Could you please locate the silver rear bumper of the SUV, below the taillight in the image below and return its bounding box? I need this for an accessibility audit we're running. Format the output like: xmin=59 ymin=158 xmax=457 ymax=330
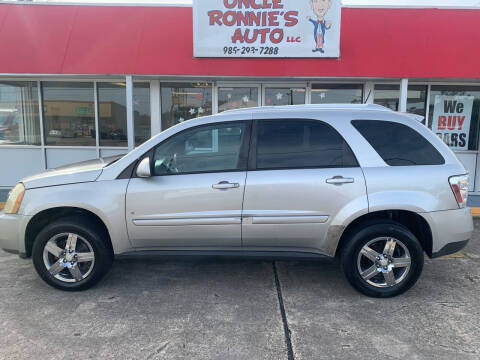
xmin=421 ymin=207 xmax=473 ymax=258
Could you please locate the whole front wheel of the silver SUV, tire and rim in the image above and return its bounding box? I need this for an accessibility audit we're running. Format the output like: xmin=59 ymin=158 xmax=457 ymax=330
xmin=32 ymin=217 xmax=113 ymax=291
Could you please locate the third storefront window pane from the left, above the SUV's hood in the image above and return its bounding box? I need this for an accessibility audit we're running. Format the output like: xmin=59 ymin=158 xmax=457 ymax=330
xmin=97 ymin=82 xmax=128 ymax=147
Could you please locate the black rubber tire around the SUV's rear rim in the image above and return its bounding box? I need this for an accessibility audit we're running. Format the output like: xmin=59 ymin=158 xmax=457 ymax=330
xmin=341 ymin=220 xmax=424 ymax=298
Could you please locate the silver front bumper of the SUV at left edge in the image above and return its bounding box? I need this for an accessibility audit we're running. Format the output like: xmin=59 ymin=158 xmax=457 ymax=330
xmin=0 ymin=211 xmax=30 ymax=254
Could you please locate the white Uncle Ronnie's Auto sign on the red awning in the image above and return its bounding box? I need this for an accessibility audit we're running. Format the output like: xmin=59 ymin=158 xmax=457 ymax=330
xmin=193 ymin=0 xmax=341 ymax=58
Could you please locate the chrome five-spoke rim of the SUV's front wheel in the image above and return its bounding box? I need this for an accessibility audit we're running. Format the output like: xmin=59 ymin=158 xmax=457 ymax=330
xmin=43 ymin=233 xmax=95 ymax=283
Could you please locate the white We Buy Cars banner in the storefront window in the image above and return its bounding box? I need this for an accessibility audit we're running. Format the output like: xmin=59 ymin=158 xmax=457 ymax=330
xmin=432 ymin=95 xmax=474 ymax=150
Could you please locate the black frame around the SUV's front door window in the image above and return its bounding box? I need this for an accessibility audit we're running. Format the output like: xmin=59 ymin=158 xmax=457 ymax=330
xmin=131 ymin=120 xmax=252 ymax=179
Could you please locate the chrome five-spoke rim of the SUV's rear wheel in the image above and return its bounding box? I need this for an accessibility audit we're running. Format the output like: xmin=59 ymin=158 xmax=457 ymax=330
xmin=357 ymin=237 xmax=412 ymax=288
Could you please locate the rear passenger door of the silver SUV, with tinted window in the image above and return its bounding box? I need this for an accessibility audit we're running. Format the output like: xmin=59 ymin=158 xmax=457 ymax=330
xmin=242 ymin=119 xmax=368 ymax=253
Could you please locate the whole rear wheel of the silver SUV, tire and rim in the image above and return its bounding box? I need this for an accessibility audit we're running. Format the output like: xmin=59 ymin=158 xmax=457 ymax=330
xmin=341 ymin=222 xmax=423 ymax=297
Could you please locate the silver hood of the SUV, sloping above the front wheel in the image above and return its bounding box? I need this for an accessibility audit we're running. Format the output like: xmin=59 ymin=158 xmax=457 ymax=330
xmin=20 ymin=156 xmax=120 ymax=189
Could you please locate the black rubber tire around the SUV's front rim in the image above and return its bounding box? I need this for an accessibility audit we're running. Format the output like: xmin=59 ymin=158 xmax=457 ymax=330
xmin=32 ymin=216 xmax=113 ymax=291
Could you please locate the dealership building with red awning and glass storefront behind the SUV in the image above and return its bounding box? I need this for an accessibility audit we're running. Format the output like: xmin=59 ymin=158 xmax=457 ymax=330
xmin=0 ymin=0 xmax=480 ymax=205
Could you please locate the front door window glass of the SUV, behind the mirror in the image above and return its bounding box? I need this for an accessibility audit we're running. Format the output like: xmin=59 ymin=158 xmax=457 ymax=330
xmin=153 ymin=122 xmax=248 ymax=175
